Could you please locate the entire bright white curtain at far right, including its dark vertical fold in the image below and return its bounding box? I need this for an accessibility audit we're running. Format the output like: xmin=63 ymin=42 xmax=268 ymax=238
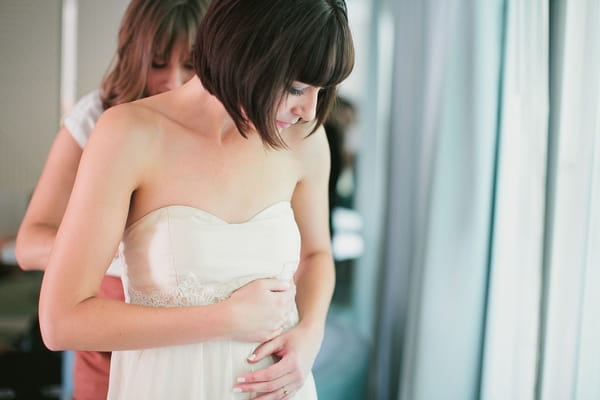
xmin=481 ymin=0 xmax=600 ymax=400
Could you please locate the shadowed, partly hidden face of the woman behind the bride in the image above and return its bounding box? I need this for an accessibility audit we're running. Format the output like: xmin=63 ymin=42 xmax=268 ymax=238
xmin=146 ymin=40 xmax=194 ymax=96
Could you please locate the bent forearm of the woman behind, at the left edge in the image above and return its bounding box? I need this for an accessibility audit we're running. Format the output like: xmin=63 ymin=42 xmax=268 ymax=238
xmin=15 ymin=224 xmax=57 ymax=271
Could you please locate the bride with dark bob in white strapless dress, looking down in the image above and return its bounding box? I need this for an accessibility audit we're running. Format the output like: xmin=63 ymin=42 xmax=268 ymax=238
xmin=40 ymin=0 xmax=354 ymax=400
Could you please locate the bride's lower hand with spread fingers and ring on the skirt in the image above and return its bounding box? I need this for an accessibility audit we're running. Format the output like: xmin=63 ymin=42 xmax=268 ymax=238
xmin=234 ymin=325 xmax=323 ymax=400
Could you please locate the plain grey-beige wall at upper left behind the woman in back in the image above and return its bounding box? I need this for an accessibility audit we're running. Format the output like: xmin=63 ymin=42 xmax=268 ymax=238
xmin=0 ymin=0 xmax=128 ymax=236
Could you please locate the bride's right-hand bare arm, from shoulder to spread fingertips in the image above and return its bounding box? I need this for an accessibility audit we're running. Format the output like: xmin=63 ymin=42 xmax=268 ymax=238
xmin=235 ymin=128 xmax=335 ymax=400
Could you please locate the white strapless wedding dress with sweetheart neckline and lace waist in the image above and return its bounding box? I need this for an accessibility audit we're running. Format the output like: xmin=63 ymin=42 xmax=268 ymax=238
xmin=108 ymin=201 xmax=317 ymax=400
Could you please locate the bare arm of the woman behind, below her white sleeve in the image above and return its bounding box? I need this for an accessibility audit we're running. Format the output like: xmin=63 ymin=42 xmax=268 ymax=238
xmin=15 ymin=127 xmax=82 ymax=270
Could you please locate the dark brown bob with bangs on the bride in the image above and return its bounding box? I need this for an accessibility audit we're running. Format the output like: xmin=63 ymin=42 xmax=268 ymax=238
xmin=194 ymin=0 xmax=354 ymax=148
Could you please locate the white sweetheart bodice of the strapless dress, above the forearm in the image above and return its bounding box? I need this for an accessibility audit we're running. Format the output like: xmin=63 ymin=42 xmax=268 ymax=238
xmin=123 ymin=201 xmax=300 ymax=306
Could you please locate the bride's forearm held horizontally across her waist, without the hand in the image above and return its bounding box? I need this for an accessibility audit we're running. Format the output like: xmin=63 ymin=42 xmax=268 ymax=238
xmin=40 ymin=296 xmax=231 ymax=351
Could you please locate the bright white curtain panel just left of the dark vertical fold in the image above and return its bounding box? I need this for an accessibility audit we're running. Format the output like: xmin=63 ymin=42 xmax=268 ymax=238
xmin=481 ymin=0 xmax=549 ymax=400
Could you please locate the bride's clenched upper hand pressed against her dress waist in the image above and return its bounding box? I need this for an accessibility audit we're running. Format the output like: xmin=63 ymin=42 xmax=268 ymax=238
xmin=226 ymin=279 xmax=296 ymax=342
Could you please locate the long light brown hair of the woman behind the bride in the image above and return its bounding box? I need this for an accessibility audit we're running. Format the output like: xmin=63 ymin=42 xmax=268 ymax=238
xmin=101 ymin=0 xmax=209 ymax=109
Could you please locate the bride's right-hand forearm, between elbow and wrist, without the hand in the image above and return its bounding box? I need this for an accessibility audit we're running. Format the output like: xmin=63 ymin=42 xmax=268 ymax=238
xmin=296 ymin=252 xmax=335 ymax=335
